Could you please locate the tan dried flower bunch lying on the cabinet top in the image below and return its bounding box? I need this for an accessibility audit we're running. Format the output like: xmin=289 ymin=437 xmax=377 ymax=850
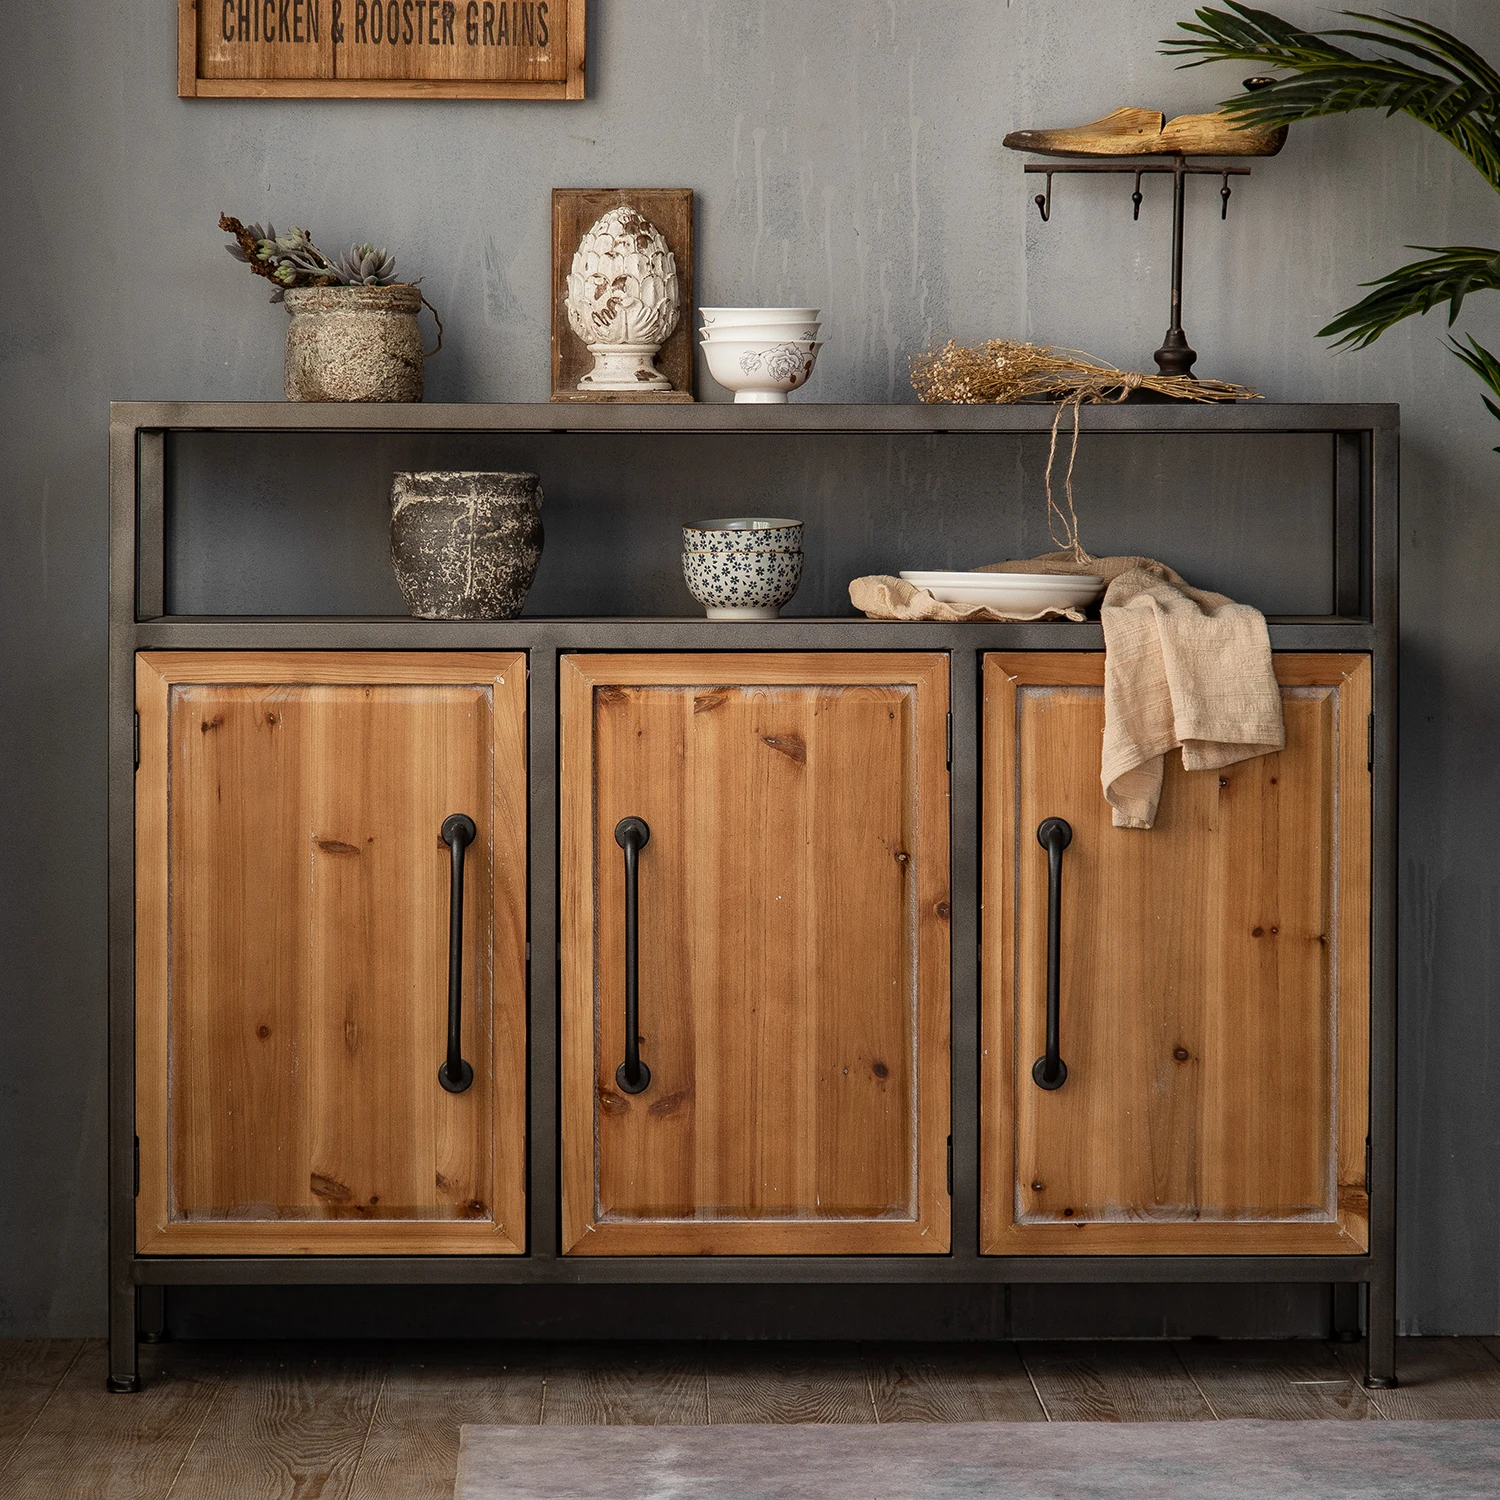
xmin=912 ymin=339 xmax=1259 ymax=405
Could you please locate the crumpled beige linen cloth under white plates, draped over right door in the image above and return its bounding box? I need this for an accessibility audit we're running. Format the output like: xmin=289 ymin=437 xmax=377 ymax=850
xmin=849 ymin=552 xmax=1286 ymax=828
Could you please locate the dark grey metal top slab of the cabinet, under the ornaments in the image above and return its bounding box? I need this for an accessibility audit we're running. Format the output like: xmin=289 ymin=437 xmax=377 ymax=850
xmin=110 ymin=401 xmax=1401 ymax=434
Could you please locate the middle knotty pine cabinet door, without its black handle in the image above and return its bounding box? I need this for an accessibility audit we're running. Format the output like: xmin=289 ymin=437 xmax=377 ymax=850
xmin=561 ymin=653 xmax=948 ymax=1256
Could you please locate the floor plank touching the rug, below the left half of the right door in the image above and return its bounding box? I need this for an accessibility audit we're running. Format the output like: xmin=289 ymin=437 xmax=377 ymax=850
xmin=1017 ymin=1343 xmax=1214 ymax=1422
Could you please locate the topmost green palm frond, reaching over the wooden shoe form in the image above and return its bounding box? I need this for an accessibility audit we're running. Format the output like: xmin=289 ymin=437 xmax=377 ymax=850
xmin=1161 ymin=0 xmax=1500 ymax=192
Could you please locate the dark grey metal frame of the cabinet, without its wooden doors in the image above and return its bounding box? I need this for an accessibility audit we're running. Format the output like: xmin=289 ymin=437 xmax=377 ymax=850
xmin=108 ymin=402 xmax=1398 ymax=1391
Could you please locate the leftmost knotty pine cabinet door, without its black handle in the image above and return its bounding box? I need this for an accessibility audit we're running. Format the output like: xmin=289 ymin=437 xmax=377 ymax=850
xmin=137 ymin=651 xmax=527 ymax=1254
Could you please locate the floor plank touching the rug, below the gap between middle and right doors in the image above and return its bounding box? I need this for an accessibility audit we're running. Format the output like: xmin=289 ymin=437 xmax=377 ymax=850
xmin=864 ymin=1344 xmax=1047 ymax=1422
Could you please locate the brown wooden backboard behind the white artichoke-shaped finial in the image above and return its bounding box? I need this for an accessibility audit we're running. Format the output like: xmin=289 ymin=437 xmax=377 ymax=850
xmin=552 ymin=188 xmax=698 ymax=404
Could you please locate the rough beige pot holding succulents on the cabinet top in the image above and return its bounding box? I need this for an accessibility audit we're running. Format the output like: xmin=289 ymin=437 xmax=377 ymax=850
xmin=287 ymin=287 xmax=423 ymax=401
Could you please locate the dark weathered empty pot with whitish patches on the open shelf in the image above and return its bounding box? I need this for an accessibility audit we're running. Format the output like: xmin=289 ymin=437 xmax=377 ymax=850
xmin=390 ymin=473 xmax=542 ymax=620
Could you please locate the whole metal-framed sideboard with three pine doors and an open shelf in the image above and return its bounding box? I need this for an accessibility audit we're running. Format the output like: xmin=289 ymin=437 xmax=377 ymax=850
xmin=110 ymin=404 xmax=1397 ymax=1391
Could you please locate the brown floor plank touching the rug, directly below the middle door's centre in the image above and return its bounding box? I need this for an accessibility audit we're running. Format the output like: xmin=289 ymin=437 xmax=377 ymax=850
xmin=708 ymin=1344 xmax=876 ymax=1424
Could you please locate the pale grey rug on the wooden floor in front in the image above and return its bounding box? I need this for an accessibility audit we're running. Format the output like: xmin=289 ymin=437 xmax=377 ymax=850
xmin=456 ymin=1422 xmax=1500 ymax=1500
